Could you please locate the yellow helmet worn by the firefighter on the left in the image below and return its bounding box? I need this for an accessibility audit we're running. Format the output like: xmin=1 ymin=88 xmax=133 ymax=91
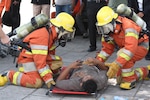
xmin=50 ymin=12 xmax=75 ymax=32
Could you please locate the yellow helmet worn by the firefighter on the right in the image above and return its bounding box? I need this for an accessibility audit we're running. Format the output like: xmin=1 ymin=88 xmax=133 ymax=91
xmin=96 ymin=6 xmax=118 ymax=26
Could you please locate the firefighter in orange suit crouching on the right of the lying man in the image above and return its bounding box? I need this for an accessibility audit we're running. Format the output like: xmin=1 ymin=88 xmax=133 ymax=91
xmin=96 ymin=6 xmax=150 ymax=90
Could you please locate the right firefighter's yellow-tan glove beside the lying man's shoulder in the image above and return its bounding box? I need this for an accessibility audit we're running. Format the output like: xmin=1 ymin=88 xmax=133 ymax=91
xmin=105 ymin=62 xmax=120 ymax=78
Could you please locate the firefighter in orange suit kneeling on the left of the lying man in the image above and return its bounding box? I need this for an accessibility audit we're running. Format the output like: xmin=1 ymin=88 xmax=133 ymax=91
xmin=0 ymin=12 xmax=75 ymax=88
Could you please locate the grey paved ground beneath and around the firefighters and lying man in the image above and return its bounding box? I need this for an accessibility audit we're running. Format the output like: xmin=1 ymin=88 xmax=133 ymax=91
xmin=0 ymin=36 xmax=150 ymax=100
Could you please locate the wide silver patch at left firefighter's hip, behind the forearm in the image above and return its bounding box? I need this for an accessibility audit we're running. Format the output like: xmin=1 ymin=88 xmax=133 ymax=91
xmin=22 ymin=62 xmax=37 ymax=72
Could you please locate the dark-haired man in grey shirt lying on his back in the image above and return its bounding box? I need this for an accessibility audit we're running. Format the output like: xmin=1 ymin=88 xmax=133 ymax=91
xmin=56 ymin=58 xmax=108 ymax=93
